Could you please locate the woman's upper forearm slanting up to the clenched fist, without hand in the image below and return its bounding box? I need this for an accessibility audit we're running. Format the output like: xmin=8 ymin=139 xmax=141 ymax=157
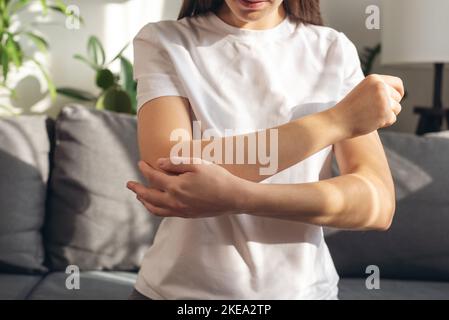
xmin=175 ymin=110 xmax=347 ymax=182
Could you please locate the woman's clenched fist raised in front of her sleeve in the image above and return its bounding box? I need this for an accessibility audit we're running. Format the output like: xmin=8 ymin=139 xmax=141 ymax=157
xmin=329 ymin=75 xmax=404 ymax=138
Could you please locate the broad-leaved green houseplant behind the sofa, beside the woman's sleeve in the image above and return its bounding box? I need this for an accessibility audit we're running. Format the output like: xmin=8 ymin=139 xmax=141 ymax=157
xmin=57 ymin=36 xmax=137 ymax=114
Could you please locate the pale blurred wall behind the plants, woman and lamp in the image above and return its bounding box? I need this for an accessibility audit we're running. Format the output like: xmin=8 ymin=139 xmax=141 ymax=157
xmin=0 ymin=0 xmax=449 ymax=132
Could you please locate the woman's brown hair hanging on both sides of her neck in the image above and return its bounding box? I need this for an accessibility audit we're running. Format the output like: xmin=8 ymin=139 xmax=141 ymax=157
xmin=178 ymin=0 xmax=323 ymax=26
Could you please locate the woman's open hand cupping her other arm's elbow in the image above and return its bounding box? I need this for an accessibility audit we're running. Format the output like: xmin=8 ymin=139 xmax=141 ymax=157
xmin=127 ymin=159 xmax=251 ymax=218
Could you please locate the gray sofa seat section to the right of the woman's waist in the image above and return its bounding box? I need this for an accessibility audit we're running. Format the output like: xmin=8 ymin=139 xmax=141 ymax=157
xmin=338 ymin=278 xmax=449 ymax=300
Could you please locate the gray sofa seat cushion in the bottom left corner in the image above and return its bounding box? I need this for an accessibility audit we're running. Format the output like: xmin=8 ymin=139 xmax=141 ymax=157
xmin=0 ymin=273 xmax=44 ymax=300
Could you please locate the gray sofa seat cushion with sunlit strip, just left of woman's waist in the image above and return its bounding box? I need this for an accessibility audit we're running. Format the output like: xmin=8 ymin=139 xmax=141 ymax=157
xmin=28 ymin=271 xmax=137 ymax=300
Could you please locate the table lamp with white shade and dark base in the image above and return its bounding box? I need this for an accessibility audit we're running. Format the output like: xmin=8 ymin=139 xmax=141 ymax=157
xmin=381 ymin=0 xmax=449 ymax=135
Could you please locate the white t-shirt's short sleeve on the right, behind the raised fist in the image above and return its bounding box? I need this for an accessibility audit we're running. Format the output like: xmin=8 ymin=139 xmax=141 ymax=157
xmin=338 ymin=32 xmax=365 ymax=99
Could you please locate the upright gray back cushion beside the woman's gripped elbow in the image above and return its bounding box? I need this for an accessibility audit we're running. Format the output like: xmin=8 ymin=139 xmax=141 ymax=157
xmin=45 ymin=106 xmax=159 ymax=271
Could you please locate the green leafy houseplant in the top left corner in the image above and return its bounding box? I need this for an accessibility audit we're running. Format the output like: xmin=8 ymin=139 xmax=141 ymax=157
xmin=0 ymin=0 xmax=76 ymax=114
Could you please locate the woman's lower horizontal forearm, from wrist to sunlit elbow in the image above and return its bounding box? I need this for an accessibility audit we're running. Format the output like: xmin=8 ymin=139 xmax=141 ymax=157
xmin=241 ymin=171 xmax=395 ymax=230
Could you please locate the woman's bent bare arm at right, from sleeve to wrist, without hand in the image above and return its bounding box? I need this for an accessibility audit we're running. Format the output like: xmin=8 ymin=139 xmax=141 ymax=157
xmin=244 ymin=131 xmax=396 ymax=230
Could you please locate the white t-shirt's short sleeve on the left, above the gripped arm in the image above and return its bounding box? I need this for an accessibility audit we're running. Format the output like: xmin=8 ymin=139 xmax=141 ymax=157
xmin=133 ymin=23 xmax=186 ymax=110
